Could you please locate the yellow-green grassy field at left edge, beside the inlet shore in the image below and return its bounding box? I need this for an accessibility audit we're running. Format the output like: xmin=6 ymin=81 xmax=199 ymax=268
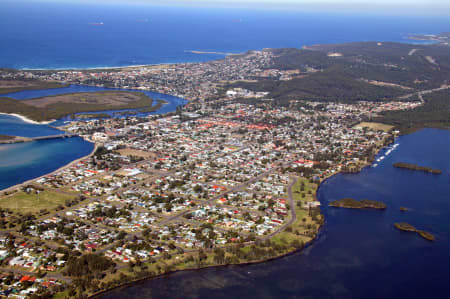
xmin=0 ymin=191 xmax=74 ymax=213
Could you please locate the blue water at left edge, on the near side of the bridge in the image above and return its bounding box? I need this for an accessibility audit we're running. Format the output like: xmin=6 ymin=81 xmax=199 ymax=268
xmin=0 ymin=137 xmax=94 ymax=190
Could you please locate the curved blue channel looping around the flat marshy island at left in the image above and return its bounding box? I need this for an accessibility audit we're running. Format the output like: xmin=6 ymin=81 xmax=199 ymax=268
xmin=0 ymin=85 xmax=188 ymax=123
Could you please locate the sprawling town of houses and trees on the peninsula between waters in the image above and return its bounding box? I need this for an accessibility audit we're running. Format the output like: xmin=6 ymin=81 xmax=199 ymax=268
xmin=0 ymin=50 xmax=422 ymax=297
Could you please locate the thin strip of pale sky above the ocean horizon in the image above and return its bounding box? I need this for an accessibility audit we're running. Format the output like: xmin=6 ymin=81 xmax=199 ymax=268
xmin=15 ymin=0 xmax=450 ymax=15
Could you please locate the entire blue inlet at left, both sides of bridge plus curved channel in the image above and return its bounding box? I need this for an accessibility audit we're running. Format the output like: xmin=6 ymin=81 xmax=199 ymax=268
xmin=0 ymin=85 xmax=187 ymax=190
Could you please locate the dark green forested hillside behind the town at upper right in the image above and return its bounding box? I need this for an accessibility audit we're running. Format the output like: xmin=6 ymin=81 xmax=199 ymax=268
xmin=232 ymin=42 xmax=450 ymax=105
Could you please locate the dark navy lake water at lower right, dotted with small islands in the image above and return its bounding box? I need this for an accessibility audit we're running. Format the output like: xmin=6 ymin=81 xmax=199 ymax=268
xmin=103 ymin=129 xmax=450 ymax=298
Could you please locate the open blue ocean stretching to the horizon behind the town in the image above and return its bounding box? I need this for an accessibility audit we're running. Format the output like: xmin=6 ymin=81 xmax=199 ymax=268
xmin=0 ymin=0 xmax=450 ymax=68
